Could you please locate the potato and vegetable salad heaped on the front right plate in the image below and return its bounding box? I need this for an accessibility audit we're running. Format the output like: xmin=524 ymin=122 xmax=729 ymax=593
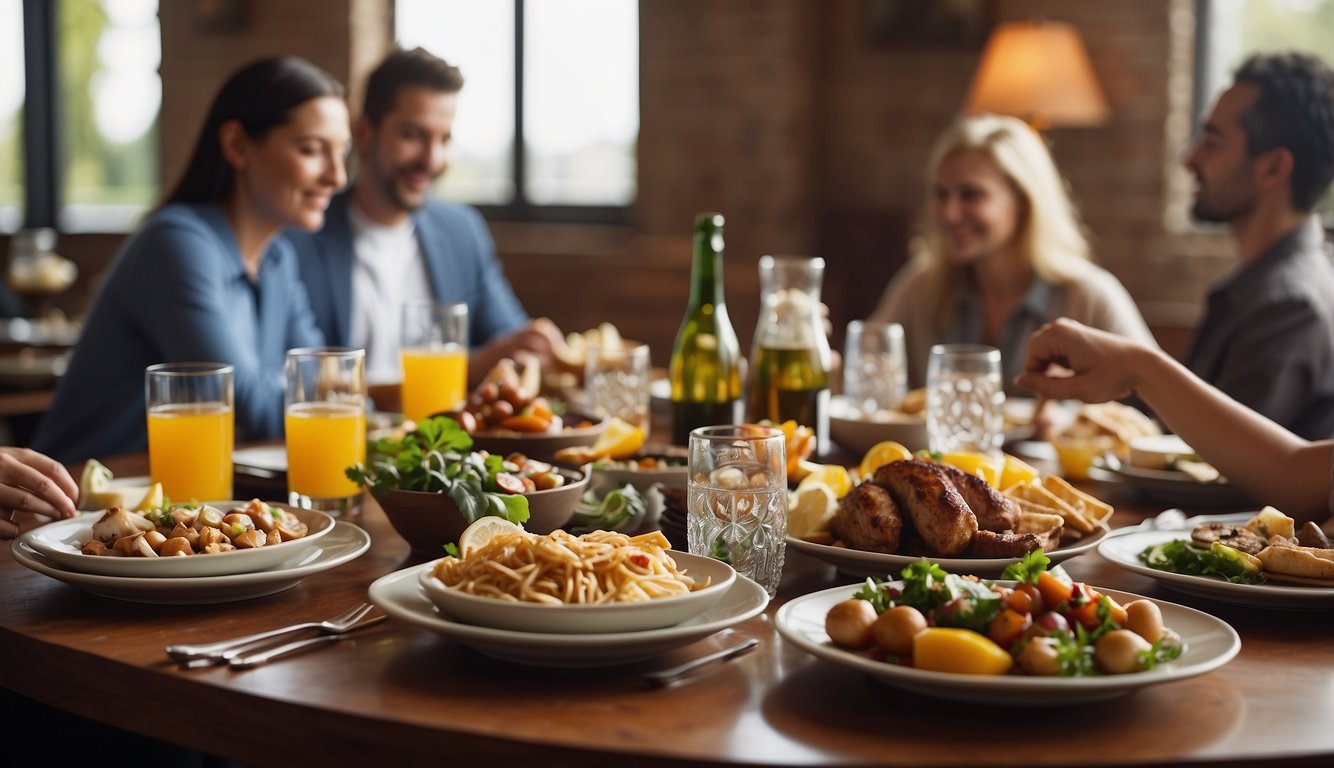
xmin=824 ymin=551 xmax=1185 ymax=677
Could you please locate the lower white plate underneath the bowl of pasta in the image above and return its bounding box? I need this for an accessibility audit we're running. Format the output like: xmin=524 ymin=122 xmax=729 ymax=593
xmin=371 ymin=563 xmax=768 ymax=668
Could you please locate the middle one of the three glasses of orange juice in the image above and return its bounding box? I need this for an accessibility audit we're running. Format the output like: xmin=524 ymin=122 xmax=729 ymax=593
xmin=284 ymin=347 xmax=366 ymax=517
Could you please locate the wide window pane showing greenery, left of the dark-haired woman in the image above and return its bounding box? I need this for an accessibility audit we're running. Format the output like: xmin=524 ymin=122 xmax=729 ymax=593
xmin=56 ymin=0 xmax=161 ymax=231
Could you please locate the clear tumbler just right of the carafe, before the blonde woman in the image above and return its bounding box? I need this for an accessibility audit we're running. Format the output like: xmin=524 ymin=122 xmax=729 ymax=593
xmin=843 ymin=320 xmax=908 ymax=417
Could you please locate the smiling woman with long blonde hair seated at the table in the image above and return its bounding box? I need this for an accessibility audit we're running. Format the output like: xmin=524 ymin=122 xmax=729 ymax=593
xmin=870 ymin=115 xmax=1157 ymax=387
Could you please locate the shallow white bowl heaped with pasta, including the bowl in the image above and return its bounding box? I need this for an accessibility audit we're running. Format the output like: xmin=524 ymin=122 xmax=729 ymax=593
xmin=419 ymin=527 xmax=736 ymax=635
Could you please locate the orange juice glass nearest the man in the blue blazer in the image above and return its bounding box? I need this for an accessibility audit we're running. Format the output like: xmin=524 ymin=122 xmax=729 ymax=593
xmin=399 ymin=301 xmax=468 ymax=421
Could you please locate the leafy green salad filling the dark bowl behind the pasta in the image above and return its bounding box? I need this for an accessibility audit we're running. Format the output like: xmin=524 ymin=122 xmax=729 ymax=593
xmin=347 ymin=416 xmax=566 ymax=525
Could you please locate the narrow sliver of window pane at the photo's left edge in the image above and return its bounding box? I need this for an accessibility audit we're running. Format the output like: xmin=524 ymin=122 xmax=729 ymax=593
xmin=0 ymin=0 xmax=24 ymax=232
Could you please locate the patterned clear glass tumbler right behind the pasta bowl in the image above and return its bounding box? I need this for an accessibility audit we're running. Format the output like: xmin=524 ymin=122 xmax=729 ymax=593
xmin=686 ymin=424 xmax=787 ymax=597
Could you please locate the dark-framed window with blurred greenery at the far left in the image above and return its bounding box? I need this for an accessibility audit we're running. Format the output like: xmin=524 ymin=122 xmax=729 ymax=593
xmin=0 ymin=0 xmax=161 ymax=232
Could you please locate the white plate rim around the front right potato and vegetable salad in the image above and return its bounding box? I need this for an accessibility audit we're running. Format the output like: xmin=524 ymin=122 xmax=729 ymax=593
xmin=774 ymin=584 xmax=1242 ymax=704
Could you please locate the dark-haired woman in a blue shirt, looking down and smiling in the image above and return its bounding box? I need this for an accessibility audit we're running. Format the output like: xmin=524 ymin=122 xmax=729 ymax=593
xmin=33 ymin=57 xmax=350 ymax=463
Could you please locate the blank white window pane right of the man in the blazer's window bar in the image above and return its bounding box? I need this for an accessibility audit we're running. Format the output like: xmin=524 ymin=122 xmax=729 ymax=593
xmin=523 ymin=0 xmax=639 ymax=205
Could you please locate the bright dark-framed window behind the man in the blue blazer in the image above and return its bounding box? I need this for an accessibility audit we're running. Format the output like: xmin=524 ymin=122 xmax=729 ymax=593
xmin=395 ymin=0 xmax=639 ymax=224
